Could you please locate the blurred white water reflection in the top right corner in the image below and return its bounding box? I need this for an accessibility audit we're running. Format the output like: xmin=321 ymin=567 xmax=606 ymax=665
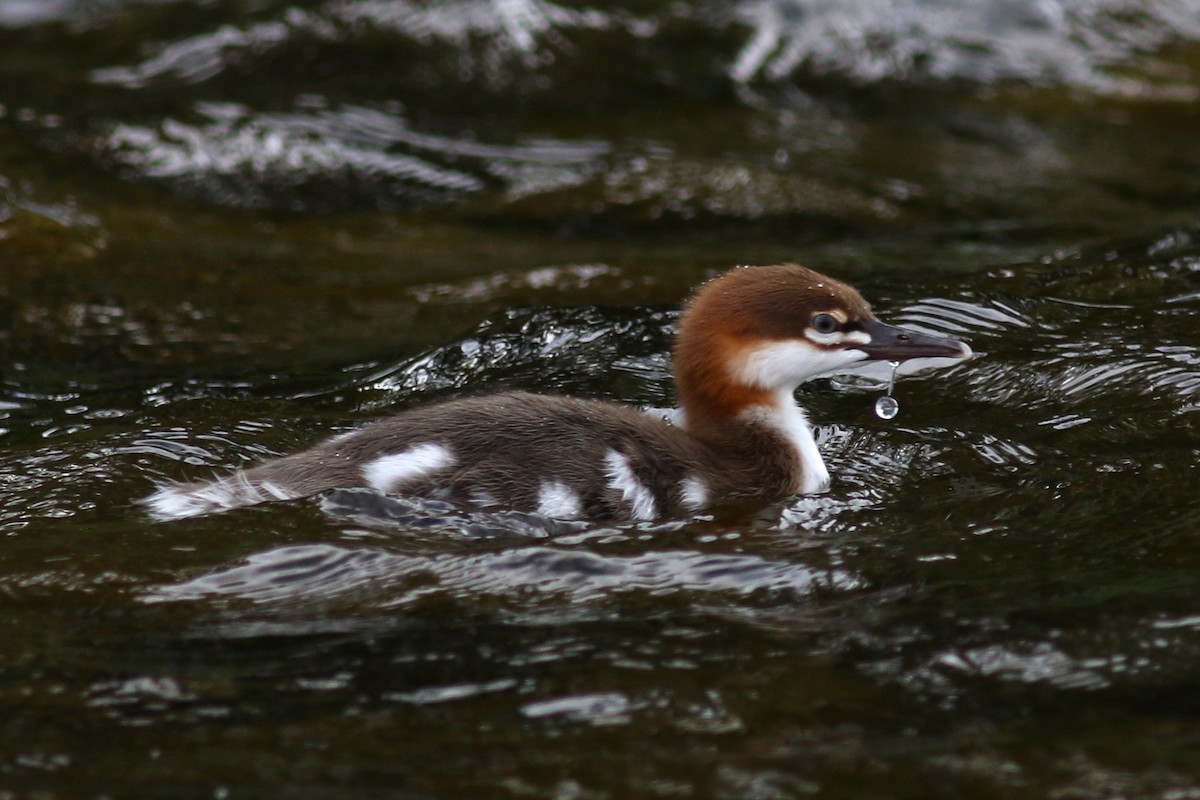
xmin=731 ymin=0 xmax=1200 ymax=92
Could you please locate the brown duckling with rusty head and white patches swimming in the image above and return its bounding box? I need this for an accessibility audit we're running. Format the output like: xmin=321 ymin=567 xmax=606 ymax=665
xmin=143 ymin=264 xmax=971 ymax=521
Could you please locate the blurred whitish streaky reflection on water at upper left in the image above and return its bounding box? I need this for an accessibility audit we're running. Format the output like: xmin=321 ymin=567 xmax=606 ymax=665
xmin=106 ymin=100 xmax=607 ymax=207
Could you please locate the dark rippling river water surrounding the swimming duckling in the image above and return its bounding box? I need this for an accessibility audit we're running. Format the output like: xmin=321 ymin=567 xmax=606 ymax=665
xmin=0 ymin=0 xmax=1200 ymax=800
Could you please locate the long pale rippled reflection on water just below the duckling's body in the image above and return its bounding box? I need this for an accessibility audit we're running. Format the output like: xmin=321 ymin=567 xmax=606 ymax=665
xmin=145 ymin=534 xmax=862 ymax=610
